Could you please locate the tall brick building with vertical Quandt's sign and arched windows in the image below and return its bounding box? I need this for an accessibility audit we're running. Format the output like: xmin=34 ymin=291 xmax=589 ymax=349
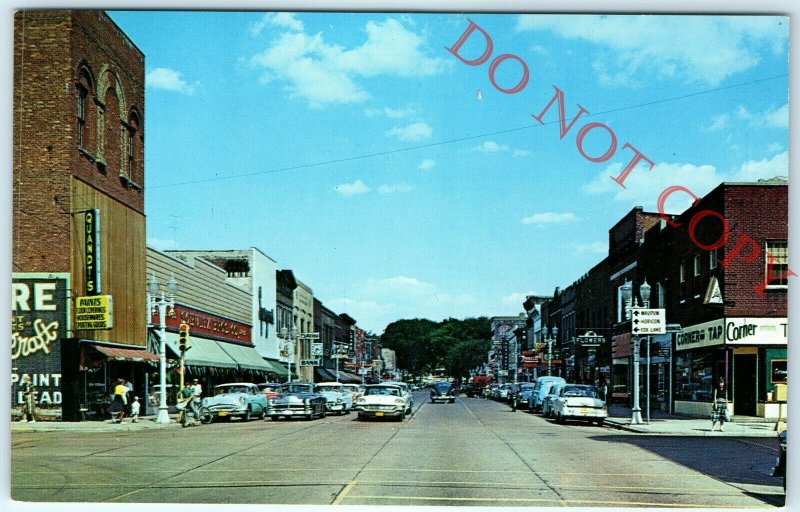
xmin=12 ymin=10 xmax=148 ymax=419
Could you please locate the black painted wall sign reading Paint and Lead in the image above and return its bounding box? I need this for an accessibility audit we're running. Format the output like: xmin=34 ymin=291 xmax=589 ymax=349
xmin=11 ymin=273 xmax=70 ymax=409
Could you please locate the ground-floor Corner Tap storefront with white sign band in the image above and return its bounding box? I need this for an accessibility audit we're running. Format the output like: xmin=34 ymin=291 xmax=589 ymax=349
xmin=674 ymin=317 xmax=788 ymax=418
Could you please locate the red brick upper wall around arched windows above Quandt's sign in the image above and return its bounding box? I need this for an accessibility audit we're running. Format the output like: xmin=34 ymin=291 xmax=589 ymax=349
xmin=12 ymin=10 xmax=144 ymax=272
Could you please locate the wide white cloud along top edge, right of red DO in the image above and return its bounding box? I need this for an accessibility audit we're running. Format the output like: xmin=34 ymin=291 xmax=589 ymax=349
xmin=516 ymin=14 xmax=789 ymax=86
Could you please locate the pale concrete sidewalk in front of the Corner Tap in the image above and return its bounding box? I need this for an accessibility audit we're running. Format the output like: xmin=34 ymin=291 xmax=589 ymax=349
xmin=606 ymin=405 xmax=778 ymax=437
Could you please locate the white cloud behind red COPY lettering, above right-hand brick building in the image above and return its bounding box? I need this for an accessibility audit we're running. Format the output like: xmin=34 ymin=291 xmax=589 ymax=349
xmin=582 ymin=151 xmax=789 ymax=213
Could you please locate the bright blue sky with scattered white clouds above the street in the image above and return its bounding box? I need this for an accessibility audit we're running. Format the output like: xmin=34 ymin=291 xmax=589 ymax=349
xmin=104 ymin=11 xmax=789 ymax=333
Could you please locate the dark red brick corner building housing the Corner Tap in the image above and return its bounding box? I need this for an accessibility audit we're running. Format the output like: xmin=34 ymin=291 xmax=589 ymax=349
xmin=638 ymin=179 xmax=788 ymax=417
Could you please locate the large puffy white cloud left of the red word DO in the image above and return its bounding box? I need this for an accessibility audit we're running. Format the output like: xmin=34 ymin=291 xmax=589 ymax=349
xmin=250 ymin=18 xmax=445 ymax=107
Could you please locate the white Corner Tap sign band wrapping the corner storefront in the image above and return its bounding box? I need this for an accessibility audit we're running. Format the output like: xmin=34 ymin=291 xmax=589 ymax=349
xmin=675 ymin=317 xmax=788 ymax=350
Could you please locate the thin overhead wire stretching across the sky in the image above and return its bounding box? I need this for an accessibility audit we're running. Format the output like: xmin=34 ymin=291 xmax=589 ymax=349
xmin=139 ymin=73 xmax=789 ymax=190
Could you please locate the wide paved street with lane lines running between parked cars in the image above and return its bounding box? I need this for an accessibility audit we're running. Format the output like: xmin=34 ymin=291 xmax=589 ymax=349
xmin=11 ymin=393 xmax=783 ymax=508
